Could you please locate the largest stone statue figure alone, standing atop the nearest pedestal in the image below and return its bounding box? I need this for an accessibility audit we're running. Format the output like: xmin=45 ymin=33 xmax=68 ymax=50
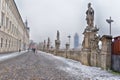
xmin=86 ymin=3 xmax=94 ymax=27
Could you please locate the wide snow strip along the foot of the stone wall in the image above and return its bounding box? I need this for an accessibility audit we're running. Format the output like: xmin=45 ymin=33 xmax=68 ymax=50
xmin=40 ymin=52 xmax=120 ymax=80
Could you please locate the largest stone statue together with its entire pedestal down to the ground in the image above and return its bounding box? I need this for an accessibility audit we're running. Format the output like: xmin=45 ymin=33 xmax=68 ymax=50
xmin=81 ymin=3 xmax=100 ymax=66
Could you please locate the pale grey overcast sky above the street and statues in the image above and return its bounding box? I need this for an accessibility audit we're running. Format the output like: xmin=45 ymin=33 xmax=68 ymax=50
xmin=15 ymin=0 xmax=120 ymax=46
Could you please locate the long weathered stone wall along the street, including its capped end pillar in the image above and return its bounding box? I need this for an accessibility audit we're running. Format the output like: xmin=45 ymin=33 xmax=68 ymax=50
xmin=44 ymin=35 xmax=114 ymax=69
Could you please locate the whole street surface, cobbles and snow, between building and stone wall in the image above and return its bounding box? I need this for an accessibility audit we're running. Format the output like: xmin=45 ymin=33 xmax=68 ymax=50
xmin=0 ymin=51 xmax=120 ymax=80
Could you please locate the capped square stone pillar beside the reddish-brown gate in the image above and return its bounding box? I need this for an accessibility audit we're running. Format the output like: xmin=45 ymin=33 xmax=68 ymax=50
xmin=100 ymin=35 xmax=112 ymax=69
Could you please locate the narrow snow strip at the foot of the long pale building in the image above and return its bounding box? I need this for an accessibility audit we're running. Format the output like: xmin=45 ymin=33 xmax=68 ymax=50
xmin=0 ymin=51 xmax=26 ymax=61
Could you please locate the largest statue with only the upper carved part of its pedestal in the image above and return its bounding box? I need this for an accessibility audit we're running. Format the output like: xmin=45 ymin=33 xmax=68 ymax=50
xmin=82 ymin=3 xmax=100 ymax=51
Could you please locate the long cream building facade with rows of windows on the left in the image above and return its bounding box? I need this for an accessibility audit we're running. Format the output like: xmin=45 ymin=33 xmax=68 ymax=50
xmin=0 ymin=0 xmax=29 ymax=53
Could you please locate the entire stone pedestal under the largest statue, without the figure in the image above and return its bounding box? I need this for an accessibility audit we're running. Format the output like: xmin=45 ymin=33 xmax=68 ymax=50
xmin=82 ymin=27 xmax=99 ymax=66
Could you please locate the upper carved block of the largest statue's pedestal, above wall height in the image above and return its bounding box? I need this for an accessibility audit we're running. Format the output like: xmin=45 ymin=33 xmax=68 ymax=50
xmin=82 ymin=26 xmax=99 ymax=49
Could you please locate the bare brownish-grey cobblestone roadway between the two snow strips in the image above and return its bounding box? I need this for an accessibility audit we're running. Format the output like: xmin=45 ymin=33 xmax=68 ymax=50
xmin=0 ymin=52 xmax=79 ymax=80
